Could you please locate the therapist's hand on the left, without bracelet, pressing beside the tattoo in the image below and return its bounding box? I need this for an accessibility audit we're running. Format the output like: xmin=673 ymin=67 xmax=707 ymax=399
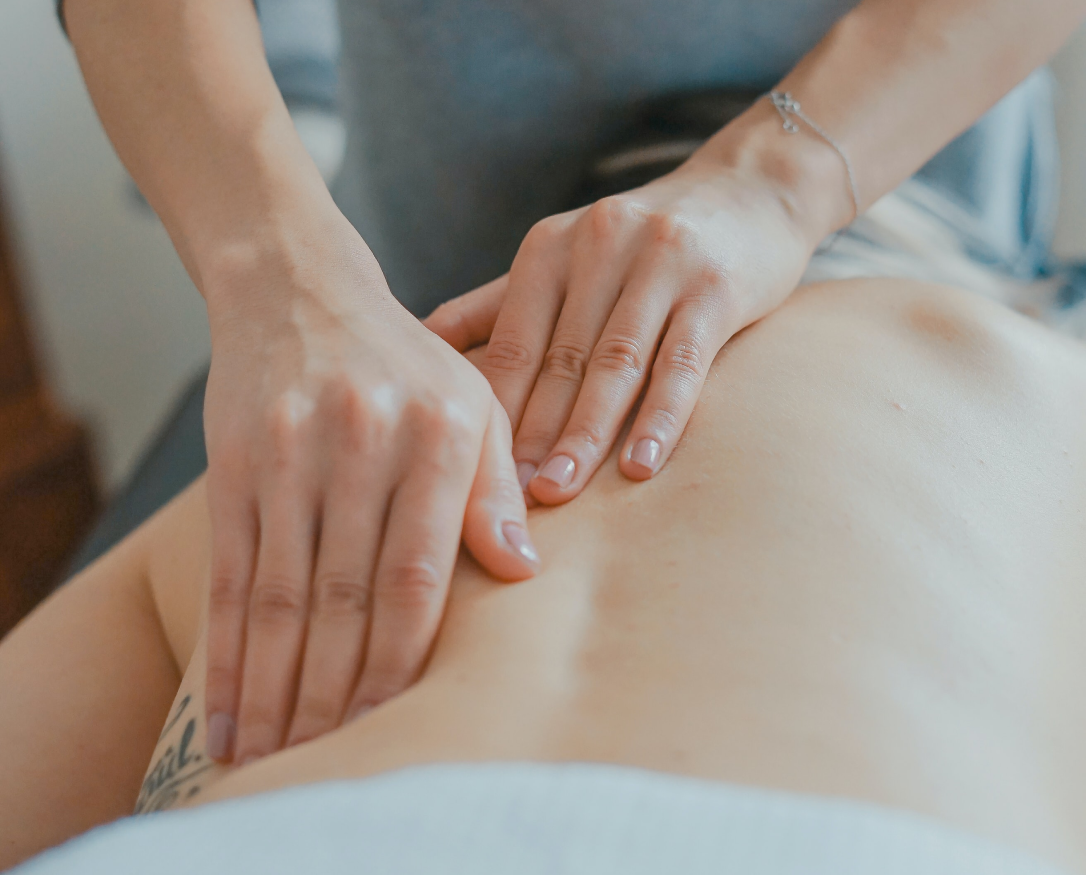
xmin=204 ymin=220 xmax=539 ymax=763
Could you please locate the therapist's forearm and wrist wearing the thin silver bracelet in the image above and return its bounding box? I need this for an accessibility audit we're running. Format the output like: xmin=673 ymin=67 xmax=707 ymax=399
xmin=705 ymin=0 xmax=1086 ymax=249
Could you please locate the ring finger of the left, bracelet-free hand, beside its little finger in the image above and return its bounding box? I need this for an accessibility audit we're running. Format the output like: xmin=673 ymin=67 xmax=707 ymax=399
xmin=229 ymin=484 xmax=317 ymax=764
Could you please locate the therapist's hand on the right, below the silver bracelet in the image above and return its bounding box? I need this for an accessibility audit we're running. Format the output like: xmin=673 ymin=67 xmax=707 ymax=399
xmin=426 ymin=147 xmax=829 ymax=505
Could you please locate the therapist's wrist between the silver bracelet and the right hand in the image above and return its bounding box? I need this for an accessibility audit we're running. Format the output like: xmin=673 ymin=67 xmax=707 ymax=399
xmin=691 ymin=99 xmax=856 ymax=252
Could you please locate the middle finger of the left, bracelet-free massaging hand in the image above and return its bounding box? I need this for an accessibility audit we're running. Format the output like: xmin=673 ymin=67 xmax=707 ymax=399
xmin=287 ymin=466 xmax=390 ymax=746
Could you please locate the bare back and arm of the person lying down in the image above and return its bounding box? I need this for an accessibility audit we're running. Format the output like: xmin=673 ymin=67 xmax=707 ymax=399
xmin=0 ymin=280 xmax=1086 ymax=872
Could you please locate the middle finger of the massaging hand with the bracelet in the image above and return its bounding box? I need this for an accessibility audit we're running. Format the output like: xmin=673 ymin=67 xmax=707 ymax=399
xmin=513 ymin=199 xmax=637 ymax=486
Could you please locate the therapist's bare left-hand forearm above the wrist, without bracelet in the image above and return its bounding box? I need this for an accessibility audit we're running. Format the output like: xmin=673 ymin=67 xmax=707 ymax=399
xmin=65 ymin=0 xmax=343 ymax=303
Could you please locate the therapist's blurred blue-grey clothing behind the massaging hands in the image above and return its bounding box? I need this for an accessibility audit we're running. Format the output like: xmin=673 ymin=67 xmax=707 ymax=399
xmin=336 ymin=0 xmax=1058 ymax=314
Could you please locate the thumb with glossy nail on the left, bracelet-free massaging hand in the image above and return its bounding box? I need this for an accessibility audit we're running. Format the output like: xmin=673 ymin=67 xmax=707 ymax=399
xmin=464 ymin=398 xmax=540 ymax=581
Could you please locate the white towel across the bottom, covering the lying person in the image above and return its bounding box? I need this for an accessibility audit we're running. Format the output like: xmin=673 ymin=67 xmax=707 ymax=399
xmin=13 ymin=763 xmax=1057 ymax=875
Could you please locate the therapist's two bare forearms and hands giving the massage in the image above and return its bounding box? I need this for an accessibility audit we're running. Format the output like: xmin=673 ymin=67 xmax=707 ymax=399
xmin=65 ymin=0 xmax=1086 ymax=761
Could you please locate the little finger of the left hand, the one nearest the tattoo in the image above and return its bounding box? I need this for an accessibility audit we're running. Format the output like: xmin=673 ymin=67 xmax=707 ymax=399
xmin=205 ymin=465 xmax=257 ymax=762
